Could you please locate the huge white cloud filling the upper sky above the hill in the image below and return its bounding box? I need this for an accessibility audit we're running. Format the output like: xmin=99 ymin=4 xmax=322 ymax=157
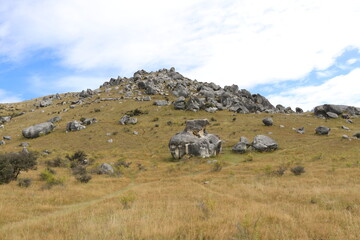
xmin=0 ymin=0 xmax=360 ymax=104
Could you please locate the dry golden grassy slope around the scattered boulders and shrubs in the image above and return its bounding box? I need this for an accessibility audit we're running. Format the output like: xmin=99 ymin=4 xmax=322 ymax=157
xmin=0 ymin=89 xmax=360 ymax=239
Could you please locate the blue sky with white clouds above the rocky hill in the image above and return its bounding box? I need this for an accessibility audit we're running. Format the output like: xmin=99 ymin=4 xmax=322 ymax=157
xmin=0 ymin=0 xmax=360 ymax=110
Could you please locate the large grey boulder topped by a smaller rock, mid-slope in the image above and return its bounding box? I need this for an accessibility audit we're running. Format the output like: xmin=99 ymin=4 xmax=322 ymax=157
xmin=169 ymin=119 xmax=222 ymax=159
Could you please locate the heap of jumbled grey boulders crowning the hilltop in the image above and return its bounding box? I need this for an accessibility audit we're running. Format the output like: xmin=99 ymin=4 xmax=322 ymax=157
xmin=95 ymin=68 xmax=284 ymax=113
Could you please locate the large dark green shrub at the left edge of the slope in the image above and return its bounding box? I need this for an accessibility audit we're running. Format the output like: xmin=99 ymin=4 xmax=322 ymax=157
xmin=0 ymin=152 xmax=37 ymax=184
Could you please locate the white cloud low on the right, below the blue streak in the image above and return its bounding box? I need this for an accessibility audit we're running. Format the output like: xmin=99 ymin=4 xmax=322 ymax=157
xmin=268 ymin=69 xmax=360 ymax=110
